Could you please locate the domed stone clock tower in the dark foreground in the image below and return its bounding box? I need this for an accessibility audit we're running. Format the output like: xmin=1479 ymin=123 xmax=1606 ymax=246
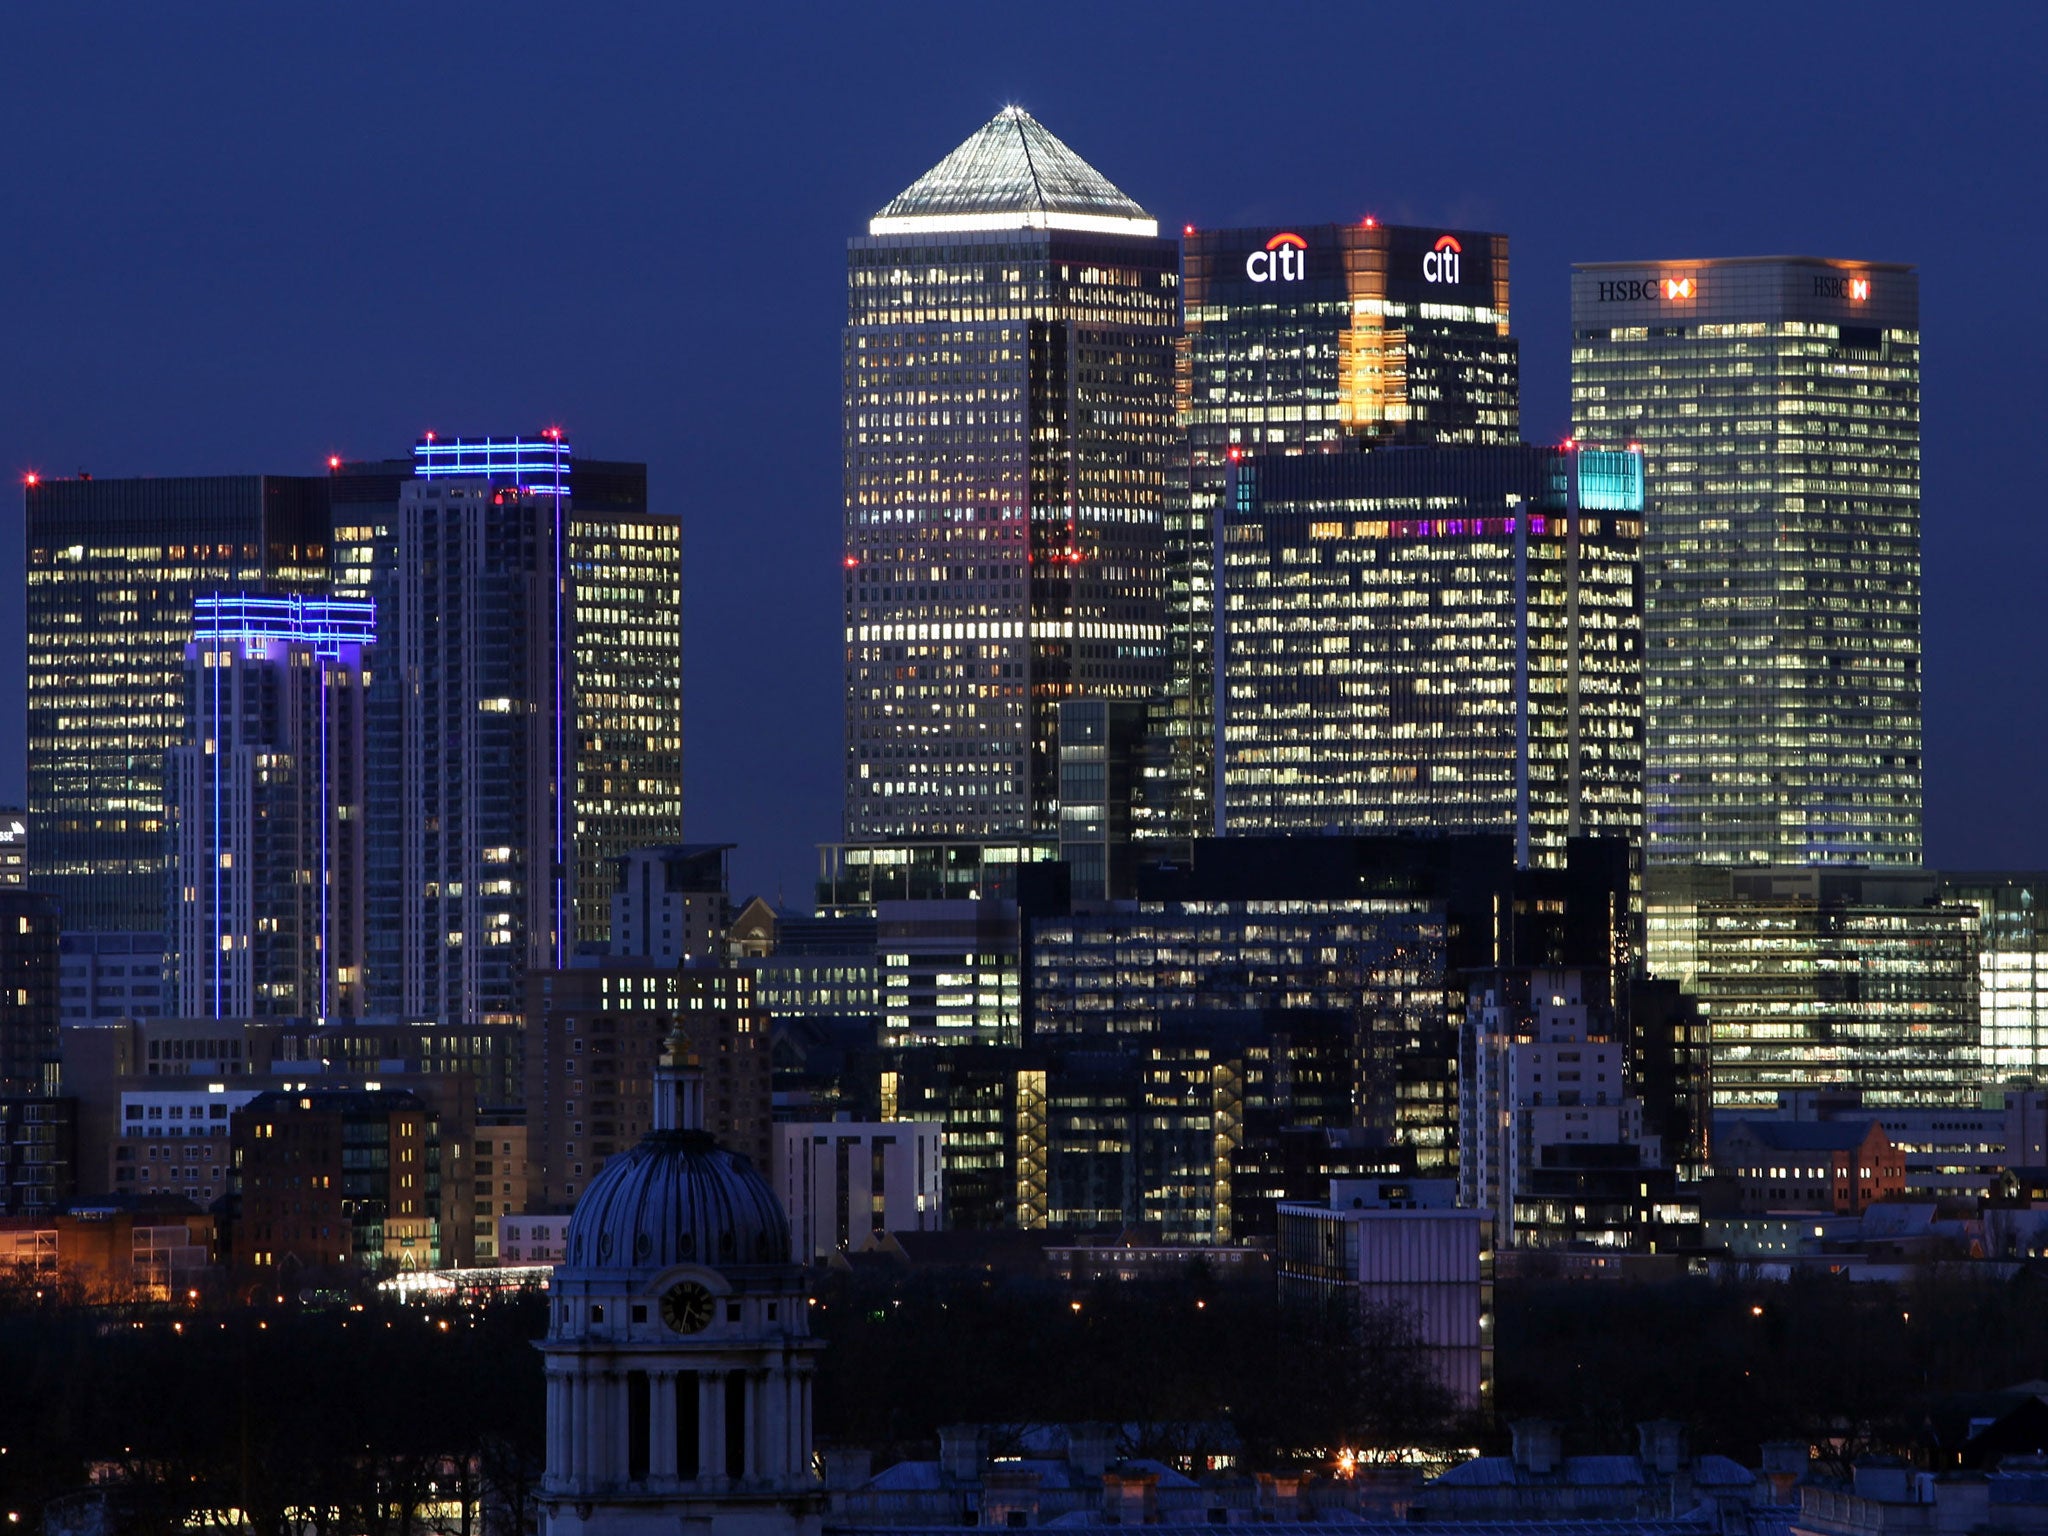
xmin=541 ymin=1032 xmax=823 ymax=1536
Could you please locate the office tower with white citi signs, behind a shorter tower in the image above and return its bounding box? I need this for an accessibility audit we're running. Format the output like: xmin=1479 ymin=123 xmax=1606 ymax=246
xmin=1155 ymin=219 xmax=1522 ymax=836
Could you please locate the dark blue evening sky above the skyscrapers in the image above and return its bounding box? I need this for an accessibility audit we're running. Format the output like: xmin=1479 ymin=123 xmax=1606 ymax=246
xmin=0 ymin=0 xmax=2048 ymax=899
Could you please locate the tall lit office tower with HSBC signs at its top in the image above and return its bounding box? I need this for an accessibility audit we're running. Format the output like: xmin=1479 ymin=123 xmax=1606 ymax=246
xmin=1571 ymin=256 xmax=1921 ymax=864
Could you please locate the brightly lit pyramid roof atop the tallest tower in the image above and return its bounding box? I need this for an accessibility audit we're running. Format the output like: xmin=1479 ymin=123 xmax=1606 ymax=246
xmin=868 ymin=106 xmax=1159 ymax=236
